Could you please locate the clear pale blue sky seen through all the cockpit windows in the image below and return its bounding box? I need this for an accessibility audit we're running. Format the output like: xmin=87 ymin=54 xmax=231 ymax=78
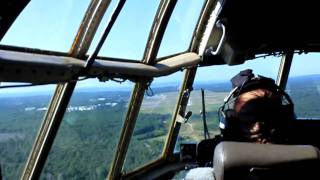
xmin=0 ymin=0 xmax=320 ymax=95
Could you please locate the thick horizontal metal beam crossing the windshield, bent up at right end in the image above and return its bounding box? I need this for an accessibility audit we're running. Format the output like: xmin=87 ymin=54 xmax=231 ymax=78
xmin=0 ymin=49 xmax=200 ymax=85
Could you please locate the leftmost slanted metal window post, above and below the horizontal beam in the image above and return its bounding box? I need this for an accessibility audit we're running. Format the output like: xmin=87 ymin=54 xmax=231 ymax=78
xmin=21 ymin=0 xmax=110 ymax=179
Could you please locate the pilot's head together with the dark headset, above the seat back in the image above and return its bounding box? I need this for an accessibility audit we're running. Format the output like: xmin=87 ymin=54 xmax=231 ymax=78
xmin=220 ymin=69 xmax=295 ymax=144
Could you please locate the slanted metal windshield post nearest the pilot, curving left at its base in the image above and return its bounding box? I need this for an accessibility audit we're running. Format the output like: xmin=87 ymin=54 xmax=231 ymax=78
xmin=115 ymin=0 xmax=212 ymax=179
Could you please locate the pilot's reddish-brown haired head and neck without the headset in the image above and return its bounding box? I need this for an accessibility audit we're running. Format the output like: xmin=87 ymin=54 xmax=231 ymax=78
xmin=234 ymin=88 xmax=280 ymax=144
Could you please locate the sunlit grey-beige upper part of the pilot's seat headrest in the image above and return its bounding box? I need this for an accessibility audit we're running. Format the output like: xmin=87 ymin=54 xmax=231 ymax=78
xmin=213 ymin=141 xmax=320 ymax=180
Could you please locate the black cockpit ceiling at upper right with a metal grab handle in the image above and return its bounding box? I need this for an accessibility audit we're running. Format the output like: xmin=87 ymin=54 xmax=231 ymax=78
xmin=199 ymin=0 xmax=320 ymax=66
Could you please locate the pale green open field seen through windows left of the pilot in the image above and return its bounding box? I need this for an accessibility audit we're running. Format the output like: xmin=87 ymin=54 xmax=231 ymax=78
xmin=141 ymin=90 xmax=228 ymax=141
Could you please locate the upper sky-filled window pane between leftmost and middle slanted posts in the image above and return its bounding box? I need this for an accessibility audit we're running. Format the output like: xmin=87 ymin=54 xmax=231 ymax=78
xmin=95 ymin=0 xmax=160 ymax=60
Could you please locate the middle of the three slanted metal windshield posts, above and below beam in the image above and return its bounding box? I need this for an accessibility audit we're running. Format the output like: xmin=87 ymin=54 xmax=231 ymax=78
xmin=108 ymin=0 xmax=177 ymax=180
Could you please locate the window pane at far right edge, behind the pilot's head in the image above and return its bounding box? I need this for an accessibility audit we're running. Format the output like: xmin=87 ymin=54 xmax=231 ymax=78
xmin=286 ymin=53 xmax=320 ymax=118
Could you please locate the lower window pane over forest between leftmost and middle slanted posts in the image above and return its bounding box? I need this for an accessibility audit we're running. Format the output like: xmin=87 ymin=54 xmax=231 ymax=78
xmin=41 ymin=79 xmax=132 ymax=179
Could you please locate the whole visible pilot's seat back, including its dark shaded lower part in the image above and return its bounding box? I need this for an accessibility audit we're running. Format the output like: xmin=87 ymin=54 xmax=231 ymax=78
xmin=213 ymin=141 xmax=320 ymax=180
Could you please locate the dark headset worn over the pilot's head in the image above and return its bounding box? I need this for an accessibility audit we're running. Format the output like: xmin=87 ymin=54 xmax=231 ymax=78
xmin=218 ymin=69 xmax=295 ymax=140
